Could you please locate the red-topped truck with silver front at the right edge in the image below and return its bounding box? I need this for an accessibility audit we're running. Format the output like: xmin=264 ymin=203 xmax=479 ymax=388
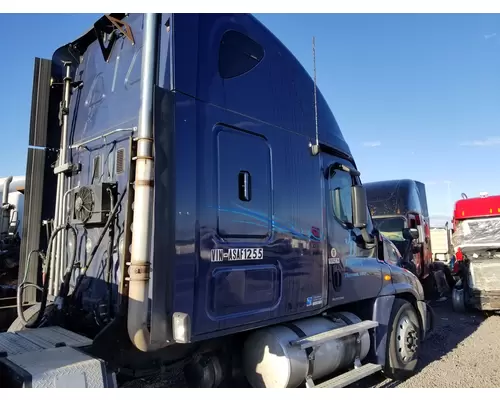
xmin=452 ymin=193 xmax=500 ymax=311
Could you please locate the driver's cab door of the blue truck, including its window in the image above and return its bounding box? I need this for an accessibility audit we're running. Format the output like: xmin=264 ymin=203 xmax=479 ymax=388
xmin=324 ymin=157 xmax=382 ymax=306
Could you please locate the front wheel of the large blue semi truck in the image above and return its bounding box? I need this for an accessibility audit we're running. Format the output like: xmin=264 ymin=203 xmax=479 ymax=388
xmin=384 ymin=298 xmax=422 ymax=381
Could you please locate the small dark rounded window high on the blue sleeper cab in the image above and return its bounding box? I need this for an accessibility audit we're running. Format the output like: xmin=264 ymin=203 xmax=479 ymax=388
xmin=219 ymin=31 xmax=264 ymax=79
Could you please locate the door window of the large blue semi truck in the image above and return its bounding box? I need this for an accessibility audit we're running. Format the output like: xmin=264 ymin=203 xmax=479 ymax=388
xmin=329 ymin=169 xmax=352 ymax=227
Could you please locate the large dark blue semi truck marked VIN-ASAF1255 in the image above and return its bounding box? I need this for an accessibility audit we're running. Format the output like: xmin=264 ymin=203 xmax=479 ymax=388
xmin=0 ymin=13 xmax=429 ymax=388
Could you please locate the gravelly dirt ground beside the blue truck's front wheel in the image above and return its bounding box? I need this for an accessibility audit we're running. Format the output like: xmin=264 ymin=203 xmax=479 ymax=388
xmin=358 ymin=302 xmax=500 ymax=388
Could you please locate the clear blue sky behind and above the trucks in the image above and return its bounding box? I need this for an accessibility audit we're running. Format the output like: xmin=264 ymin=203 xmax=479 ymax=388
xmin=0 ymin=14 xmax=500 ymax=225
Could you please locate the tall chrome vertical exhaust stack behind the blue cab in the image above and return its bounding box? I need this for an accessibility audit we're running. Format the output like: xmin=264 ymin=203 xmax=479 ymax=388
xmin=127 ymin=13 xmax=161 ymax=352
